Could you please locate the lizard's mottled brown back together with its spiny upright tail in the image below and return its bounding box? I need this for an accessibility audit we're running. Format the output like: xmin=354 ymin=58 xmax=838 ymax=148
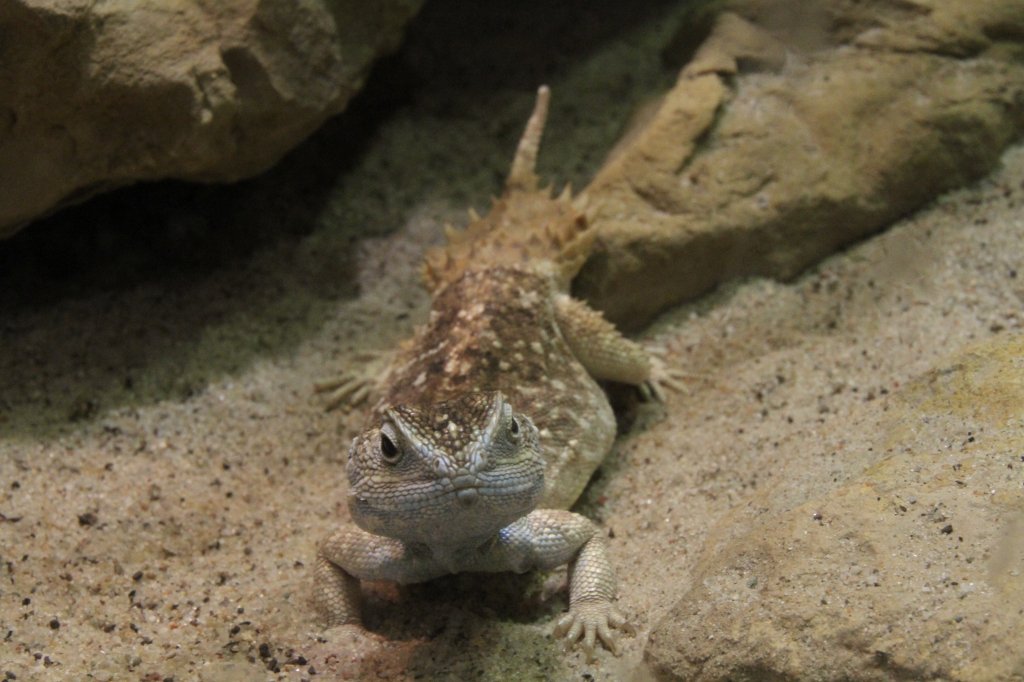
xmin=364 ymin=88 xmax=615 ymax=508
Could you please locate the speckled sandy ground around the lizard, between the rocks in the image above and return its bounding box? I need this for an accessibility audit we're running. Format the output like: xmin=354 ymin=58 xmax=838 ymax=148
xmin=0 ymin=2 xmax=1024 ymax=680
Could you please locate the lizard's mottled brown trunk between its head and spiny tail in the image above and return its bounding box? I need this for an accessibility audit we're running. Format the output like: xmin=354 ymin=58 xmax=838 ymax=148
xmin=375 ymin=266 xmax=615 ymax=508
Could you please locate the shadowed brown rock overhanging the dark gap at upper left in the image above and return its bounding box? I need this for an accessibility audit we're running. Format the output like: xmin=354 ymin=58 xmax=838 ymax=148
xmin=0 ymin=0 xmax=422 ymax=238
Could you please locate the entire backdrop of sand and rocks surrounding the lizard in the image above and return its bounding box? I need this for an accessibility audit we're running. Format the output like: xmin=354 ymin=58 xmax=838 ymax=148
xmin=0 ymin=0 xmax=1024 ymax=680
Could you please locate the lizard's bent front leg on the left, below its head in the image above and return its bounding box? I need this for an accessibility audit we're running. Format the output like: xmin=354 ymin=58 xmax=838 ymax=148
xmin=313 ymin=528 xmax=444 ymax=628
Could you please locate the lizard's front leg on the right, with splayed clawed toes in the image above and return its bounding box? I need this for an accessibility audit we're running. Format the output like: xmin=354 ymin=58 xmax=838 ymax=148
xmin=476 ymin=509 xmax=632 ymax=659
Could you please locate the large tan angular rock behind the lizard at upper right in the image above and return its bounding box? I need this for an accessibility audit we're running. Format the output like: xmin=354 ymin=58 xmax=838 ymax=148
xmin=574 ymin=0 xmax=1024 ymax=328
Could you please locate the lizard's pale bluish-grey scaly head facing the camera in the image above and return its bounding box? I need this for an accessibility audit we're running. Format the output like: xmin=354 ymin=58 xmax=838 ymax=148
xmin=346 ymin=391 xmax=544 ymax=545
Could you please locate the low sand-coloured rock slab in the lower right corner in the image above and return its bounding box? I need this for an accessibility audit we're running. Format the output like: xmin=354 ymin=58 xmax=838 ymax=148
xmin=645 ymin=335 xmax=1024 ymax=680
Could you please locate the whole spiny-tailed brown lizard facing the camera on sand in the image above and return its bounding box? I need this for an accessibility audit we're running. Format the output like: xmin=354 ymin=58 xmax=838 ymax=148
xmin=313 ymin=86 xmax=672 ymax=658
